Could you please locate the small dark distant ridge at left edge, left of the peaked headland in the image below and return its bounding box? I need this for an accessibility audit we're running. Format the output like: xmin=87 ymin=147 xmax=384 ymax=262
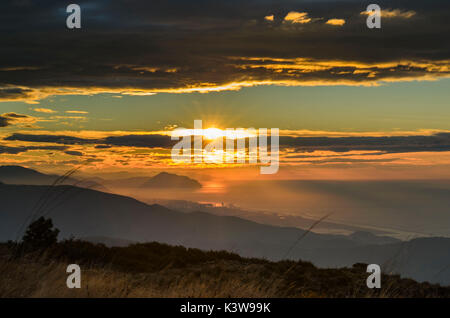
xmin=0 ymin=166 xmax=108 ymax=192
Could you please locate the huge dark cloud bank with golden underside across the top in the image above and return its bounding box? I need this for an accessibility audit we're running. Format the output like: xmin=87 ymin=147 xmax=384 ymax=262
xmin=0 ymin=0 xmax=450 ymax=100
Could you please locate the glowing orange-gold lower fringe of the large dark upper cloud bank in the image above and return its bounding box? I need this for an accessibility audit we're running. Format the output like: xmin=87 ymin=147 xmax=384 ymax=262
xmin=0 ymin=56 xmax=450 ymax=102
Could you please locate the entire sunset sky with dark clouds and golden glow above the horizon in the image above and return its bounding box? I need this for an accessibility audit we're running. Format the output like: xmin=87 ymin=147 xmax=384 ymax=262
xmin=0 ymin=0 xmax=450 ymax=180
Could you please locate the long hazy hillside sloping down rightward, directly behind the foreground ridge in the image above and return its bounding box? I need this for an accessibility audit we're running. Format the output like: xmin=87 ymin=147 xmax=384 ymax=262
xmin=0 ymin=184 xmax=450 ymax=285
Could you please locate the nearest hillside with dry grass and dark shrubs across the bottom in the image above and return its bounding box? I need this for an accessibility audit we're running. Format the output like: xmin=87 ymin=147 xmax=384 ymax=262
xmin=0 ymin=241 xmax=450 ymax=297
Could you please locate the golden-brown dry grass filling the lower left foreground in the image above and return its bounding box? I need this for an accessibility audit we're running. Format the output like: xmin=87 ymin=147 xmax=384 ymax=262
xmin=0 ymin=261 xmax=281 ymax=298
